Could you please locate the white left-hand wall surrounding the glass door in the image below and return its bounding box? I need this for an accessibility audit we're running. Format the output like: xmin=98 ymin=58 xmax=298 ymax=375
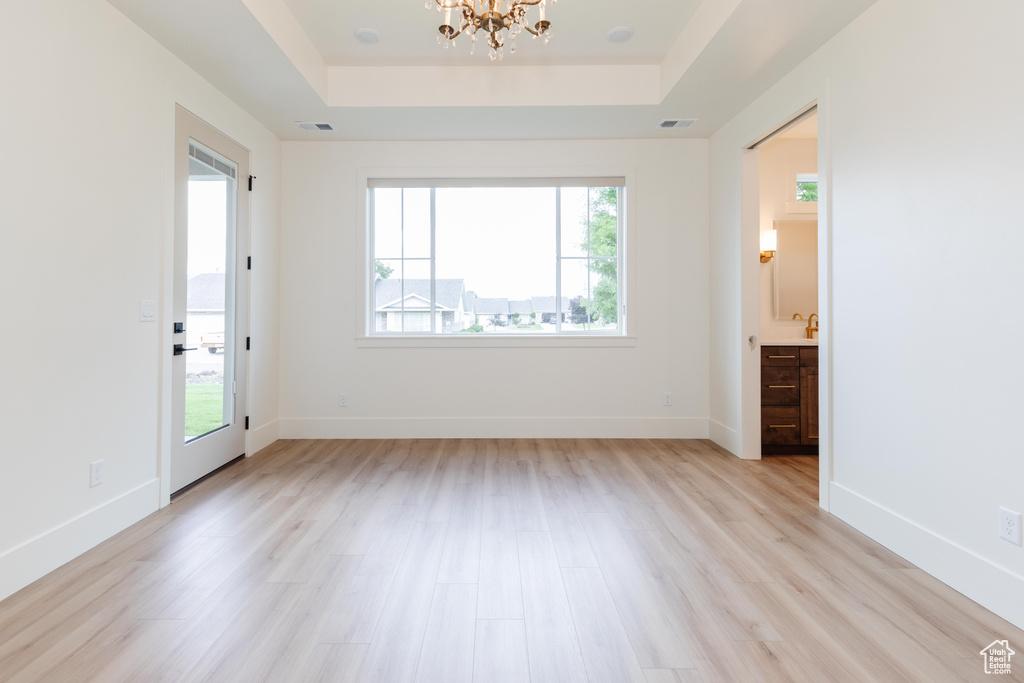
xmin=0 ymin=0 xmax=280 ymax=598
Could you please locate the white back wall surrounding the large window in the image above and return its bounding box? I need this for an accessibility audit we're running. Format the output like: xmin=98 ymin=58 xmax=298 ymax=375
xmin=281 ymin=140 xmax=709 ymax=437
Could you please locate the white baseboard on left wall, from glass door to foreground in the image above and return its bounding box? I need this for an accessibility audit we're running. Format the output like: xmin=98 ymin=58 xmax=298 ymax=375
xmin=0 ymin=479 xmax=160 ymax=600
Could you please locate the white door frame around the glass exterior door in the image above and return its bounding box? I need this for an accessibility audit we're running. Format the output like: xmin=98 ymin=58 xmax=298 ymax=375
xmin=157 ymin=105 xmax=255 ymax=508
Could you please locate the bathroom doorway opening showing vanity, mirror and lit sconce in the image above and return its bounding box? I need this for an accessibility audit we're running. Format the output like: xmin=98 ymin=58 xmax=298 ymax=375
xmin=742 ymin=104 xmax=829 ymax=507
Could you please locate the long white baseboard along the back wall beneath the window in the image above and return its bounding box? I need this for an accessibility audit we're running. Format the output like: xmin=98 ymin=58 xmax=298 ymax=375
xmin=280 ymin=418 xmax=708 ymax=438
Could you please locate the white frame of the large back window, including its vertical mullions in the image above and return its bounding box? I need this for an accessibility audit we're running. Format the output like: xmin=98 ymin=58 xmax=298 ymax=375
xmin=354 ymin=172 xmax=637 ymax=347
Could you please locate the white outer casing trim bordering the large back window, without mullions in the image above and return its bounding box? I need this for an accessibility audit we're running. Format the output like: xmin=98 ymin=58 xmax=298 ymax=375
xmin=352 ymin=166 xmax=641 ymax=348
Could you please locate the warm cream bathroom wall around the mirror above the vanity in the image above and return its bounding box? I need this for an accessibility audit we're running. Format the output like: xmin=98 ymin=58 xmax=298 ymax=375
xmin=758 ymin=138 xmax=818 ymax=343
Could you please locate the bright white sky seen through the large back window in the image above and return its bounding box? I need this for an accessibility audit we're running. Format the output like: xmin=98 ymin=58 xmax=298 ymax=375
xmin=374 ymin=187 xmax=596 ymax=299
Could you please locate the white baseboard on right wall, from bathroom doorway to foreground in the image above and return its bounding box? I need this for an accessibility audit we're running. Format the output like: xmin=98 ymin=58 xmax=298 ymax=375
xmin=829 ymin=481 xmax=1024 ymax=630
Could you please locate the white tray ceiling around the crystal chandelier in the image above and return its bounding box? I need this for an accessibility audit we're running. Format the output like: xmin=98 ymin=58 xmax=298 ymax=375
xmin=109 ymin=0 xmax=874 ymax=140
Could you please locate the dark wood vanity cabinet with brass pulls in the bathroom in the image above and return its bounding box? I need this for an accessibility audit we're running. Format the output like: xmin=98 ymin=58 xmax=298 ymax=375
xmin=761 ymin=346 xmax=818 ymax=456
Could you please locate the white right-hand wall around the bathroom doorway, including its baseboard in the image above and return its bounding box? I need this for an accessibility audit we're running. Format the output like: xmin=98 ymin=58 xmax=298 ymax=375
xmin=711 ymin=0 xmax=1024 ymax=630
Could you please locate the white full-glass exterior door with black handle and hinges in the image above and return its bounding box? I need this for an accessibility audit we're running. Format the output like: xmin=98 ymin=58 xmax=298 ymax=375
xmin=168 ymin=108 xmax=249 ymax=493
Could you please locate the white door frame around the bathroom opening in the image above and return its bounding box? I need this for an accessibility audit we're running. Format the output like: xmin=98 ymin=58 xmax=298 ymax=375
xmin=737 ymin=85 xmax=835 ymax=510
